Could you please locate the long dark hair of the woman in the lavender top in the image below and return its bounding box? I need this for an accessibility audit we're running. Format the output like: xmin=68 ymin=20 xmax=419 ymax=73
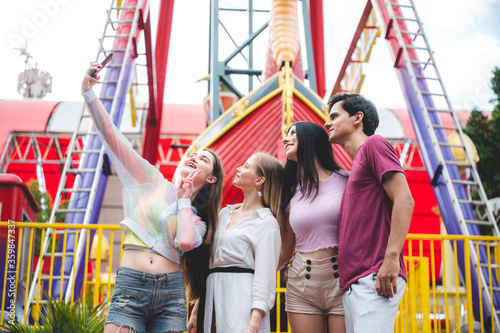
xmin=281 ymin=121 xmax=341 ymax=226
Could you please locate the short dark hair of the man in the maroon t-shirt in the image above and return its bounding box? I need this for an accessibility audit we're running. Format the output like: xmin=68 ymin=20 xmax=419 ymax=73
xmin=328 ymin=93 xmax=379 ymax=136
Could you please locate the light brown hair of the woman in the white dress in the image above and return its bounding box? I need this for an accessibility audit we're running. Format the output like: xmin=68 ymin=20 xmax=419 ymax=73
xmin=255 ymin=153 xmax=284 ymax=230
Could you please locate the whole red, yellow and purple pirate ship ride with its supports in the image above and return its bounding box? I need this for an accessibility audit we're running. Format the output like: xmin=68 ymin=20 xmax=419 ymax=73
xmin=0 ymin=0 xmax=500 ymax=331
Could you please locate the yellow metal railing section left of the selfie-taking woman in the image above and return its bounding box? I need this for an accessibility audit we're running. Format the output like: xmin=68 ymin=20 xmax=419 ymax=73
xmin=0 ymin=222 xmax=123 ymax=324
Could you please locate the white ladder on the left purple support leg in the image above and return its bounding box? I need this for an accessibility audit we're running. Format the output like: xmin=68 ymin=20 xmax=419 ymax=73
xmin=24 ymin=0 xmax=149 ymax=318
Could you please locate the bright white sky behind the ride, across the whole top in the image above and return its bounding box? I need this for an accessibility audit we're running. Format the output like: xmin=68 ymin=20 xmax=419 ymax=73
xmin=0 ymin=0 xmax=500 ymax=110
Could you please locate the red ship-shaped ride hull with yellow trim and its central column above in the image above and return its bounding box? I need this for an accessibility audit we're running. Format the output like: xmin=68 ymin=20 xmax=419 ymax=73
xmin=178 ymin=0 xmax=351 ymax=208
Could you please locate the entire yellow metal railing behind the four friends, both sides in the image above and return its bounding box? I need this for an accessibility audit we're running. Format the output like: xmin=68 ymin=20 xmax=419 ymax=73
xmin=0 ymin=222 xmax=500 ymax=333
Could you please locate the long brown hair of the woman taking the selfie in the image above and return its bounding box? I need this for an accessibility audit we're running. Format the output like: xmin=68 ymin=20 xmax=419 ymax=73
xmin=180 ymin=149 xmax=224 ymax=301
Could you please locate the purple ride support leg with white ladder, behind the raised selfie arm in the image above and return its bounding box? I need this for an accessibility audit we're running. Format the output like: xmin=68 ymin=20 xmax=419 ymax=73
xmin=24 ymin=0 xmax=149 ymax=318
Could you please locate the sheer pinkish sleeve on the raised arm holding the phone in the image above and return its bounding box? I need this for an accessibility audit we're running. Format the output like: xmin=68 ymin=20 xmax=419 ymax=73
xmin=83 ymin=89 xmax=164 ymax=187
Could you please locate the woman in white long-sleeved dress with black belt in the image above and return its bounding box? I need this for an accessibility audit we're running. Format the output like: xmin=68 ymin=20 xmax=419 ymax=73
xmin=188 ymin=153 xmax=283 ymax=333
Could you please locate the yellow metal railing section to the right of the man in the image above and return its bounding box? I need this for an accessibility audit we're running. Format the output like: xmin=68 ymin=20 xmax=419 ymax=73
xmin=395 ymin=234 xmax=500 ymax=333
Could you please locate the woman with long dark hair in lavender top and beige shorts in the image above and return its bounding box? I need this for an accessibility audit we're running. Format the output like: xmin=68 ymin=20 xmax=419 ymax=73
xmin=280 ymin=122 xmax=349 ymax=333
